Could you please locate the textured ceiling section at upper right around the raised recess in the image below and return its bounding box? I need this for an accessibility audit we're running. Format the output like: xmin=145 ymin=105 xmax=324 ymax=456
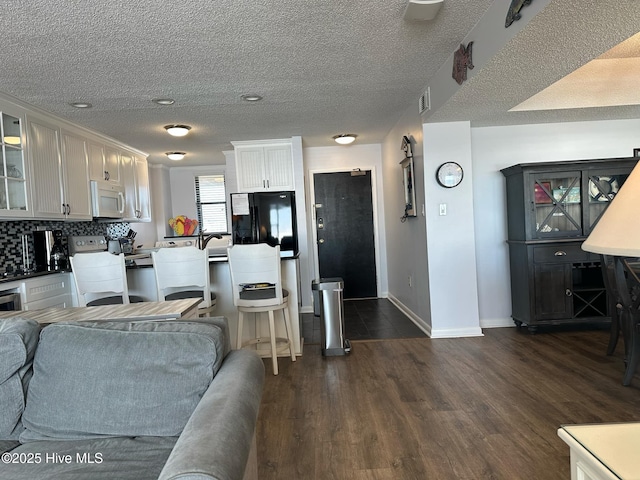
xmin=428 ymin=0 xmax=640 ymax=126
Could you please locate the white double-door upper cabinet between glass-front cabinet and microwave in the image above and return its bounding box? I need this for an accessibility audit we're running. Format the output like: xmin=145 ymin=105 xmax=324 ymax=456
xmin=27 ymin=117 xmax=91 ymax=220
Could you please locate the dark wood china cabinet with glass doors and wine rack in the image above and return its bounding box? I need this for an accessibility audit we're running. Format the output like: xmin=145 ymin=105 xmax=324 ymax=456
xmin=501 ymin=157 xmax=638 ymax=332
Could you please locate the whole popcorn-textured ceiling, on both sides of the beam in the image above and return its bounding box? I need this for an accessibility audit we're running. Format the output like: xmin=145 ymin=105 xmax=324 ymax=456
xmin=0 ymin=0 xmax=640 ymax=165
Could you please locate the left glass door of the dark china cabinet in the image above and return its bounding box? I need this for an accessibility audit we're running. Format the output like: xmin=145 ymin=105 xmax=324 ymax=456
xmin=532 ymin=172 xmax=582 ymax=238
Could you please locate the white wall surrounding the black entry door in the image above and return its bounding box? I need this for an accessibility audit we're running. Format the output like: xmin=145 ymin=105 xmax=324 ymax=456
xmin=303 ymin=143 xmax=388 ymax=304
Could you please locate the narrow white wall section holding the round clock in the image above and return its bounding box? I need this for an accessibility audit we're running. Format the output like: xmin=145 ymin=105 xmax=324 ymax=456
xmin=423 ymin=122 xmax=482 ymax=337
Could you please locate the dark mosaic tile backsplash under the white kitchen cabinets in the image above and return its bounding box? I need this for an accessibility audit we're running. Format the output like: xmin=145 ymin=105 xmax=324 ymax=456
xmin=0 ymin=220 xmax=129 ymax=269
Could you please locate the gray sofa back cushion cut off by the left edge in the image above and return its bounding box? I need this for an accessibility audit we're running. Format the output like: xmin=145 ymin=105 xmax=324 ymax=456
xmin=0 ymin=318 xmax=40 ymax=440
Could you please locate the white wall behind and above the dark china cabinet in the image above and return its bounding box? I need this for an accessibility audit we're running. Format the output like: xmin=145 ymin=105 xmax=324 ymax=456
xmin=470 ymin=120 xmax=640 ymax=327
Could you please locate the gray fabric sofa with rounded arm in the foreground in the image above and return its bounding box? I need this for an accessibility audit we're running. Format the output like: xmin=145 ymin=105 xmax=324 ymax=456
xmin=0 ymin=317 xmax=264 ymax=480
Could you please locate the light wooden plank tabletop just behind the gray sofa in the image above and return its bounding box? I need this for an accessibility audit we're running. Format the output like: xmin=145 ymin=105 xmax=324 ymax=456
xmin=0 ymin=298 xmax=201 ymax=324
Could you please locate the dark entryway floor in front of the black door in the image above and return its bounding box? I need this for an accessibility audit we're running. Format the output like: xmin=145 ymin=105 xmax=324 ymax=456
xmin=302 ymin=298 xmax=426 ymax=345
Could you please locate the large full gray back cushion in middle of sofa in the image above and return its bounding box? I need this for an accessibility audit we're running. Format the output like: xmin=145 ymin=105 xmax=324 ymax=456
xmin=20 ymin=321 xmax=225 ymax=442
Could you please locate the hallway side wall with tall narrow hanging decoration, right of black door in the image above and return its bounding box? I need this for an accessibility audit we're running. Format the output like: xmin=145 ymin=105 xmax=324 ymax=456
xmin=382 ymin=107 xmax=431 ymax=332
